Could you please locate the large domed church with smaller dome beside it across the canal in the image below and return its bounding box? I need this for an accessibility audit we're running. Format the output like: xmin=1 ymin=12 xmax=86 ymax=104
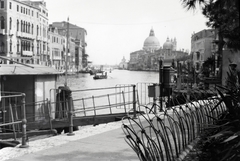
xmin=128 ymin=29 xmax=188 ymax=71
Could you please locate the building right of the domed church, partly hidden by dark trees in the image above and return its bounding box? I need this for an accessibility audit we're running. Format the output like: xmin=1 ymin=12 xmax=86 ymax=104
xmin=191 ymin=29 xmax=215 ymax=71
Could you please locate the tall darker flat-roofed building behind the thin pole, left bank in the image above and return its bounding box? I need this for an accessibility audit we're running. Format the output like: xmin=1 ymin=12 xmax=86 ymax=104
xmin=52 ymin=21 xmax=88 ymax=70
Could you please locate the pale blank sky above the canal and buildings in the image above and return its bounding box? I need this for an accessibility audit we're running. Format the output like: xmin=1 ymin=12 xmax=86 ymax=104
xmin=45 ymin=0 xmax=207 ymax=64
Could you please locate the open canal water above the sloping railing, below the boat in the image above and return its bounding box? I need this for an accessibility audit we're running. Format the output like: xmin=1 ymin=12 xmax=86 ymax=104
xmin=58 ymin=70 xmax=159 ymax=90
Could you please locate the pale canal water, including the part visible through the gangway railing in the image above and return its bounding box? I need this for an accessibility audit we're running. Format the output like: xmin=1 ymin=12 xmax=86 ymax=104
xmin=57 ymin=70 xmax=159 ymax=115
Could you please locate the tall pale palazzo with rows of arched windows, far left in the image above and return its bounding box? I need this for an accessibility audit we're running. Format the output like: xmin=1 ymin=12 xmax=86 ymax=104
xmin=0 ymin=0 xmax=48 ymax=64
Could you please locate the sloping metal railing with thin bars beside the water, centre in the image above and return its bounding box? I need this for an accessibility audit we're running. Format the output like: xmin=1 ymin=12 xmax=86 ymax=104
xmin=61 ymin=85 xmax=137 ymax=135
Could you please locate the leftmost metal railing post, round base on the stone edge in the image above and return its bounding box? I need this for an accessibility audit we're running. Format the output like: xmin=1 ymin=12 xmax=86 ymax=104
xmin=19 ymin=93 xmax=29 ymax=148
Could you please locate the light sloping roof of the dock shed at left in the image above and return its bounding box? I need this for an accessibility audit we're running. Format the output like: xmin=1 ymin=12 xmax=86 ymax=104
xmin=0 ymin=64 xmax=63 ymax=75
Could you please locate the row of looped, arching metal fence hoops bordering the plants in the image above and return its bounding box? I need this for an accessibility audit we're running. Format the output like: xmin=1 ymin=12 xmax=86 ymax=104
xmin=122 ymin=91 xmax=226 ymax=161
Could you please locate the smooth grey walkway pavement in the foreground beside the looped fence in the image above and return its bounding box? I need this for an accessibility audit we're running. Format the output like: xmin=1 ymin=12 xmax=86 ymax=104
xmin=5 ymin=128 xmax=139 ymax=161
